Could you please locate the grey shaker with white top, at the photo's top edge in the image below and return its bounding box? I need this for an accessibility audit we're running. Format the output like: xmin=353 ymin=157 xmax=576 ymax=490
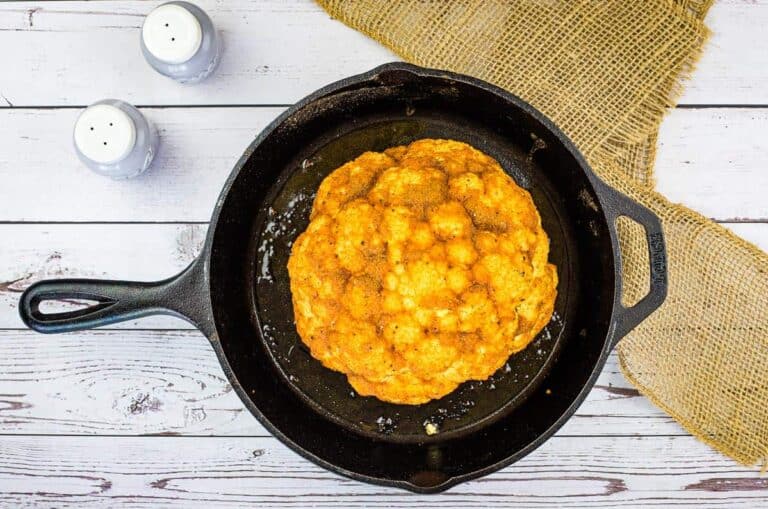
xmin=141 ymin=2 xmax=221 ymax=83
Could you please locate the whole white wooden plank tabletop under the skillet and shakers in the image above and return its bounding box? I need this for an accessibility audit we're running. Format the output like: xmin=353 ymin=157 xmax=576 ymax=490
xmin=0 ymin=0 xmax=768 ymax=508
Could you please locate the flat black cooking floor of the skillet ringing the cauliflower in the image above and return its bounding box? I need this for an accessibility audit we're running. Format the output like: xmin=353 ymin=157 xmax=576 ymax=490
xmin=253 ymin=114 xmax=578 ymax=442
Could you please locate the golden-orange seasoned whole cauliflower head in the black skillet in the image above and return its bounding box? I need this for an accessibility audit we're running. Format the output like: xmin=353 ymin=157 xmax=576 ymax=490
xmin=288 ymin=139 xmax=557 ymax=404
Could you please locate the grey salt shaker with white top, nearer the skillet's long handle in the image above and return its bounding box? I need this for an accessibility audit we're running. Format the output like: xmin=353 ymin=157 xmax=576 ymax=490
xmin=72 ymin=99 xmax=159 ymax=179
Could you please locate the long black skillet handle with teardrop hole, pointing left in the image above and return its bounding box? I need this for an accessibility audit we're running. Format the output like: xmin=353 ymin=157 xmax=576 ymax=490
xmin=19 ymin=260 xmax=212 ymax=334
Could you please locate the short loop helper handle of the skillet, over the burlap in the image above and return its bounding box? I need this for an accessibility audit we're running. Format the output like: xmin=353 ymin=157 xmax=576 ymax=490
xmin=600 ymin=183 xmax=668 ymax=345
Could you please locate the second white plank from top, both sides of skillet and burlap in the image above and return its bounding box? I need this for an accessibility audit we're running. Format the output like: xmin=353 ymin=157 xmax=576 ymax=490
xmin=0 ymin=107 xmax=768 ymax=222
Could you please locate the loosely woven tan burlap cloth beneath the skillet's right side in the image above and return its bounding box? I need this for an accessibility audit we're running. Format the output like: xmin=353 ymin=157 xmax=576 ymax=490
xmin=319 ymin=0 xmax=768 ymax=465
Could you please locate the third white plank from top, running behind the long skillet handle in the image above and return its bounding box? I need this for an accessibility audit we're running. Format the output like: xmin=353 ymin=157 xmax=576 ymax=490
xmin=0 ymin=223 xmax=768 ymax=329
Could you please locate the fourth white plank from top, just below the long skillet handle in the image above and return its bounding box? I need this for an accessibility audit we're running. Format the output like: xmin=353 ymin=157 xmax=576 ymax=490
xmin=0 ymin=330 xmax=685 ymax=436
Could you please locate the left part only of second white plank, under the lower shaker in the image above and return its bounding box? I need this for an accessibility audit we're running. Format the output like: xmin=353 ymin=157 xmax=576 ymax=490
xmin=0 ymin=108 xmax=282 ymax=222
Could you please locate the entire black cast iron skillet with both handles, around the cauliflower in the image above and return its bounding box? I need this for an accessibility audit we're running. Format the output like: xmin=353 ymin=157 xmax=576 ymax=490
xmin=20 ymin=63 xmax=667 ymax=492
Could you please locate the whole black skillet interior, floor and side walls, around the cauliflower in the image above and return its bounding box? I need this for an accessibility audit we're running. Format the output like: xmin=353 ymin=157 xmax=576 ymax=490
xmin=210 ymin=67 xmax=615 ymax=484
